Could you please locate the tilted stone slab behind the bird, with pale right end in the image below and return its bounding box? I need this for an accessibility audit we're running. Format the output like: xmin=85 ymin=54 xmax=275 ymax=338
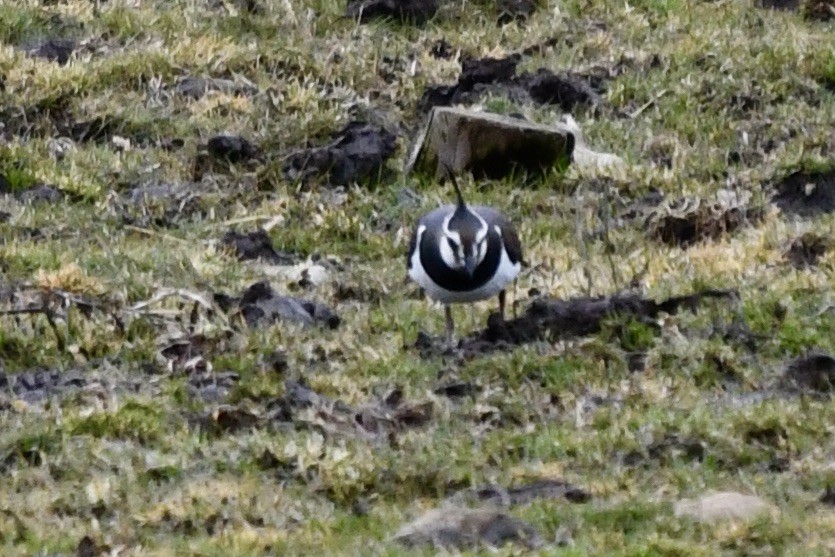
xmin=405 ymin=106 xmax=622 ymax=179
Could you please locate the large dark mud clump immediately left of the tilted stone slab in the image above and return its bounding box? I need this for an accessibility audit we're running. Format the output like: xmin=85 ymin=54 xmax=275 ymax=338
xmin=282 ymin=122 xmax=397 ymax=186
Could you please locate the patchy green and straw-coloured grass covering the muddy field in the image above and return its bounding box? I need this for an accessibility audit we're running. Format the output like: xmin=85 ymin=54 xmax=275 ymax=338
xmin=0 ymin=0 xmax=835 ymax=555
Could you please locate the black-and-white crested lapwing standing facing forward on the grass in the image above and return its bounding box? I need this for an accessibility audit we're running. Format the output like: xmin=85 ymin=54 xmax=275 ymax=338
xmin=407 ymin=172 xmax=526 ymax=347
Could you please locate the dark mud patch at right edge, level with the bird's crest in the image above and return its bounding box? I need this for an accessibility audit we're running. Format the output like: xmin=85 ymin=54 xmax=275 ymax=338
xmin=772 ymin=170 xmax=835 ymax=217
